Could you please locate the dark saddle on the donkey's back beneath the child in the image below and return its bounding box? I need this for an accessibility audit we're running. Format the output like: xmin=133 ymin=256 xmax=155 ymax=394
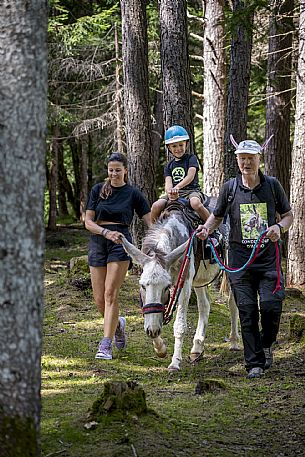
xmin=161 ymin=197 xmax=224 ymax=273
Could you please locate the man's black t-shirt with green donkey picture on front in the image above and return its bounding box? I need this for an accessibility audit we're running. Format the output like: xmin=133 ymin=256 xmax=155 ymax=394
xmin=214 ymin=171 xmax=291 ymax=270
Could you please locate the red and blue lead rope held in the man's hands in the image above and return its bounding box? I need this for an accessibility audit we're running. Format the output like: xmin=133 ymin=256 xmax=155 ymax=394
xmin=163 ymin=230 xmax=281 ymax=325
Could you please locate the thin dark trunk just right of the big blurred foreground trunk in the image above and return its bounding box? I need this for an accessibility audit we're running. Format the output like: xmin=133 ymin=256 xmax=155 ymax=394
xmin=48 ymin=125 xmax=59 ymax=230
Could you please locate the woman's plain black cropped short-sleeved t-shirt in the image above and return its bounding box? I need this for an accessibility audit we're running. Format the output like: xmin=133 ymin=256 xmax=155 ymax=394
xmin=86 ymin=183 xmax=150 ymax=225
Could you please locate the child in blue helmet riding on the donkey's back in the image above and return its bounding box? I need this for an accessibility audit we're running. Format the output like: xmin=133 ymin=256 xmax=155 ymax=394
xmin=151 ymin=125 xmax=210 ymax=222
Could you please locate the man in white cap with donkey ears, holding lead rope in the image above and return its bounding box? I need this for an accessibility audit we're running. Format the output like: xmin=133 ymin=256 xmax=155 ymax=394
xmin=197 ymin=137 xmax=293 ymax=378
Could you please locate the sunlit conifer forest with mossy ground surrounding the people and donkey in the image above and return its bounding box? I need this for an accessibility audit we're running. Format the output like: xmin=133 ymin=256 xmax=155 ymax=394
xmin=0 ymin=0 xmax=305 ymax=457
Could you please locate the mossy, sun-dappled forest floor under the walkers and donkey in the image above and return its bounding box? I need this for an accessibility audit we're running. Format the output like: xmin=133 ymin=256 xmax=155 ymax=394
xmin=41 ymin=226 xmax=305 ymax=457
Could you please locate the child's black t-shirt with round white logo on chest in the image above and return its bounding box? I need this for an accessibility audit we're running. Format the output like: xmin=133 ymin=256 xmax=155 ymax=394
xmin=164 ymin=154 xmax=200 ymax=190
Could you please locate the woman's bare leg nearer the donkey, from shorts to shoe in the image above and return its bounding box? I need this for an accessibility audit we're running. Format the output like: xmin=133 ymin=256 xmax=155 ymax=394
xmin=104 ymin=261 xmax=129 ymax=339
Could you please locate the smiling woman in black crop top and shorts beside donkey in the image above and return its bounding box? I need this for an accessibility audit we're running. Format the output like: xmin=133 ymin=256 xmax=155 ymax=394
xmin=85 ymin=152 xmax=151 ymax=360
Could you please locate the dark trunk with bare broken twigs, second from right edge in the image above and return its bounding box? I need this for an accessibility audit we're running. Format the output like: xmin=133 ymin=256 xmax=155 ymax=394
xmin=264 ymin=0 xmax=293 ymax=195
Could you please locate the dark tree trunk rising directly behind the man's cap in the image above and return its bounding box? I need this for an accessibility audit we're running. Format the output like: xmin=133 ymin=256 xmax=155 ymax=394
xmin=224 ymin=0 xmax=254 ymax=181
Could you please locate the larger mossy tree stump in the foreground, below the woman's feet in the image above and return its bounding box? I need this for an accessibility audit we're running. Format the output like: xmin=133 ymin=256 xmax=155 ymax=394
xmin=90 ymin=381 xmax=147 ymax=422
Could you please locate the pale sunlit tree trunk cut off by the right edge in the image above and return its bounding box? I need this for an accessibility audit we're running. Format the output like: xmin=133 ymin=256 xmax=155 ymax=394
xmin=287 ymin=0 xmax=305 ymax=286
